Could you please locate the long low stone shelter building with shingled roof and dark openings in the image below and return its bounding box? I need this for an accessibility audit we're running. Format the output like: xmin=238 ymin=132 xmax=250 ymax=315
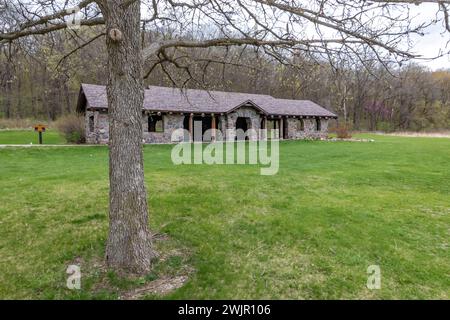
xmin=77 ymin=84 xmax=337 ymax=144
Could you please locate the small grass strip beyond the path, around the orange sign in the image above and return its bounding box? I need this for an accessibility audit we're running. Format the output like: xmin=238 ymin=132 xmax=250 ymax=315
xmin=0 ymin=129 xmax=66 ymax=144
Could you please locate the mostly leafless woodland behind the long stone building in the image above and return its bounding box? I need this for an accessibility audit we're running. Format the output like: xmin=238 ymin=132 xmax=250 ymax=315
xmin=0 ymin=31 xmax=450 ymax=131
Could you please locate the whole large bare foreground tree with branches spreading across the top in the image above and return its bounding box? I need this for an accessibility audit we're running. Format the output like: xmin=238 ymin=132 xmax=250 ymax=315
xmin=0 ymin=0 xmax=448 ymax=273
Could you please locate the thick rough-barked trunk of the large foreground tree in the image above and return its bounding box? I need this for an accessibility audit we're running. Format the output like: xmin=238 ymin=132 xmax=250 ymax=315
xmin=101 ymin=0 xmax=153 ymax=274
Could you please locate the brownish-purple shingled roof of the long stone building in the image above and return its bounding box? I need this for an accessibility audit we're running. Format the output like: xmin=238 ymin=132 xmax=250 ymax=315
xmin=77 ymin=84 xmax=337 ymax=118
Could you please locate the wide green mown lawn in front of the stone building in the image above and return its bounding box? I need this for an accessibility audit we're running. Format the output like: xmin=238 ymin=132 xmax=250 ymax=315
xmin=0 ymin=135 xmax=450 ymax=299
